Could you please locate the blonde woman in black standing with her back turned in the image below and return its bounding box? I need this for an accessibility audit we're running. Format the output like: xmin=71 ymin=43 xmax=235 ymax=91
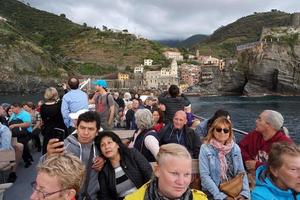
xmin=40 ymin=87 xmax=68 ymax=155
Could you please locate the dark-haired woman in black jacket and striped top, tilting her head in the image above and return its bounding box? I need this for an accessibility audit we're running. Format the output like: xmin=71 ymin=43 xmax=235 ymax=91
xmin=95 ymin=131 xmax=152 ymax=199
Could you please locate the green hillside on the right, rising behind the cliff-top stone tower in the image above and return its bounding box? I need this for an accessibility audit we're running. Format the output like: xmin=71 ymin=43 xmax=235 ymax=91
xmin=196 ymin=10 xmax=291 ymax=58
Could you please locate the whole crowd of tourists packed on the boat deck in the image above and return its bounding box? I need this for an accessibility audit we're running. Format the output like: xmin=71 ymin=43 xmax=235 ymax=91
xmin=0 ymin=77 xmax=300 ymax=200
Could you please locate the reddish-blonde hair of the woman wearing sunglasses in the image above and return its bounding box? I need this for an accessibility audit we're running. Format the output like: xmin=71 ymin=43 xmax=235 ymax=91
xmin=204 ymin=117 xmax=234 ymax=144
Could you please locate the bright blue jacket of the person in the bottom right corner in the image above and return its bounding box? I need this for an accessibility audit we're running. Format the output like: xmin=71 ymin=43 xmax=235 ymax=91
xmin=251 ymin=166 xmax=300 ymax=200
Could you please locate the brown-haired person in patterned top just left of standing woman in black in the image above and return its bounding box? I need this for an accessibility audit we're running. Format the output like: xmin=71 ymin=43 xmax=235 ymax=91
xmin=23 ymin=101 xmax=42 ymax=152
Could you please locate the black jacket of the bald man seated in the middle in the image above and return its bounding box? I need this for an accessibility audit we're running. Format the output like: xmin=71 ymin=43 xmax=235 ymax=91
xmin=158 ymin=124 xmax=201 ymax=159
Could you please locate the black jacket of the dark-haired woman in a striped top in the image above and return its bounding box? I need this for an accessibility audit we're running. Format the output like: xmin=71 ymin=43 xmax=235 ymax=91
xmin=98 ymin=148 xmax=152 ymax=200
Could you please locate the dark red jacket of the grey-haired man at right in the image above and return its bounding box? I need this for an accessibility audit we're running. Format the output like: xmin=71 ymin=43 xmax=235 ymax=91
xmin=239 ymin=130 xmax=293 ymax=168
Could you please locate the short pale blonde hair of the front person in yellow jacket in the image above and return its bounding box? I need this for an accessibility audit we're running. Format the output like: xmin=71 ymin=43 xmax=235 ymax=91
xmin=156 ymin=143 xmax=192 ymax=165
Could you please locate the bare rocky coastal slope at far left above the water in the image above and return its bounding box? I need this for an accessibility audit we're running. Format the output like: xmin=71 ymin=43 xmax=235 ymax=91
xmin=0 ymin=40 xmax=66 ymax=93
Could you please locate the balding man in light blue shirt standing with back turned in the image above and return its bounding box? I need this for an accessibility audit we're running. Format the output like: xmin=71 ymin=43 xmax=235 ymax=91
xmin=61 ymin=77 xmax=89 ymax=132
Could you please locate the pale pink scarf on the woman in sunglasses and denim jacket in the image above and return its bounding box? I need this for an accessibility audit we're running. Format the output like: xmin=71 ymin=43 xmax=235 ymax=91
xmin=209 ymin=138 xmax=234 ymax=180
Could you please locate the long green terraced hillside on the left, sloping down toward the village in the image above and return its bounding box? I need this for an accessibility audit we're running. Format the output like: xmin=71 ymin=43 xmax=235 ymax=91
xmin=0 ymin=0 xmax=166 ymax=75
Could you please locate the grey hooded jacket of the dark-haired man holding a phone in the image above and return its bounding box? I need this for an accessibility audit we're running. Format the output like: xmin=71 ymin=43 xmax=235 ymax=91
xmin=64 ymin=133 xmax=100 ymax=199
